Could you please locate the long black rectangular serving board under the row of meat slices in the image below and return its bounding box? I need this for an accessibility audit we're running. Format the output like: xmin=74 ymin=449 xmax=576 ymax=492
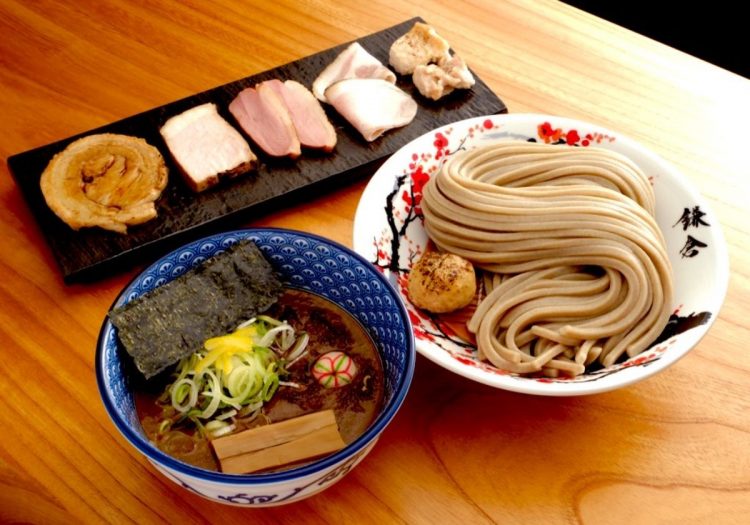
xmin=8 ymin=17 xmax=507 ymax=283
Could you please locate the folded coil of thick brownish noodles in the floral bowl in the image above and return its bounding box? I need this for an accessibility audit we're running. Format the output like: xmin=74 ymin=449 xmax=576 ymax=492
xmin=422 ymin=142 xmax=673 ymax=376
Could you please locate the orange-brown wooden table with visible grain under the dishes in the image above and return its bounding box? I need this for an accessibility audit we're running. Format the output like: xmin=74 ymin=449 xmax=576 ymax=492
xmin=0 ymin=0 xmax=750 ymax=523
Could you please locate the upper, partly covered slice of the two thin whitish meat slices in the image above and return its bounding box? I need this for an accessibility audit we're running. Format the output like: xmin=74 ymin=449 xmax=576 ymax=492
xmin=312 ymin=42 xmax=396 ymax=102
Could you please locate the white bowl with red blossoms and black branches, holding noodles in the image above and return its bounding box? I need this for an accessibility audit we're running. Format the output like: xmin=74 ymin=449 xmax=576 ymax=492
xmin=353 ymin=113 xmax=729 ymax=396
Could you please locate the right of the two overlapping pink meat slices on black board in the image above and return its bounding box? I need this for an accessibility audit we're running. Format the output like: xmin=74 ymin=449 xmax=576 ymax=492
xmin=264 ymin=80 xmax=336 ymax=152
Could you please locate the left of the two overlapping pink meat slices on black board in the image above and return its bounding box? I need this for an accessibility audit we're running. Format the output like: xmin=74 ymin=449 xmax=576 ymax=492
xmin=229 ymin=81 xmax=302 ymax=159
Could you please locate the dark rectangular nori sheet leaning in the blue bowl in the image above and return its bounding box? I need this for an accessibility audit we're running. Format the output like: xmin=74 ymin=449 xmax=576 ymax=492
xmin=109 ymin=241 xmax=282 ymax=379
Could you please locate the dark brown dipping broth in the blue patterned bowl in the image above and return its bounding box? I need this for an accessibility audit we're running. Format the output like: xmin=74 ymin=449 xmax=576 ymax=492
xmin=134 ymin=288 xmax=384 ymax=471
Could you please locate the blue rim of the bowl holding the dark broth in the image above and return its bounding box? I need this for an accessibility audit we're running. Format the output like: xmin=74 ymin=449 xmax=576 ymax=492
xmin=94 ymin=227 xmax=416 ymax=485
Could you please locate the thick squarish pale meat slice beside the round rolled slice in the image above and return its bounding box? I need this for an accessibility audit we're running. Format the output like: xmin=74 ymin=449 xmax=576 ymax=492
xmin=160 ymin=103 xmax=257 ymax=192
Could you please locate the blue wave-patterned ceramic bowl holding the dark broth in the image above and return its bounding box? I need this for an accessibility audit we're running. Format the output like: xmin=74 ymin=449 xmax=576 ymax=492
xmin=96 ymin=228 xmax=416 ymax=507
